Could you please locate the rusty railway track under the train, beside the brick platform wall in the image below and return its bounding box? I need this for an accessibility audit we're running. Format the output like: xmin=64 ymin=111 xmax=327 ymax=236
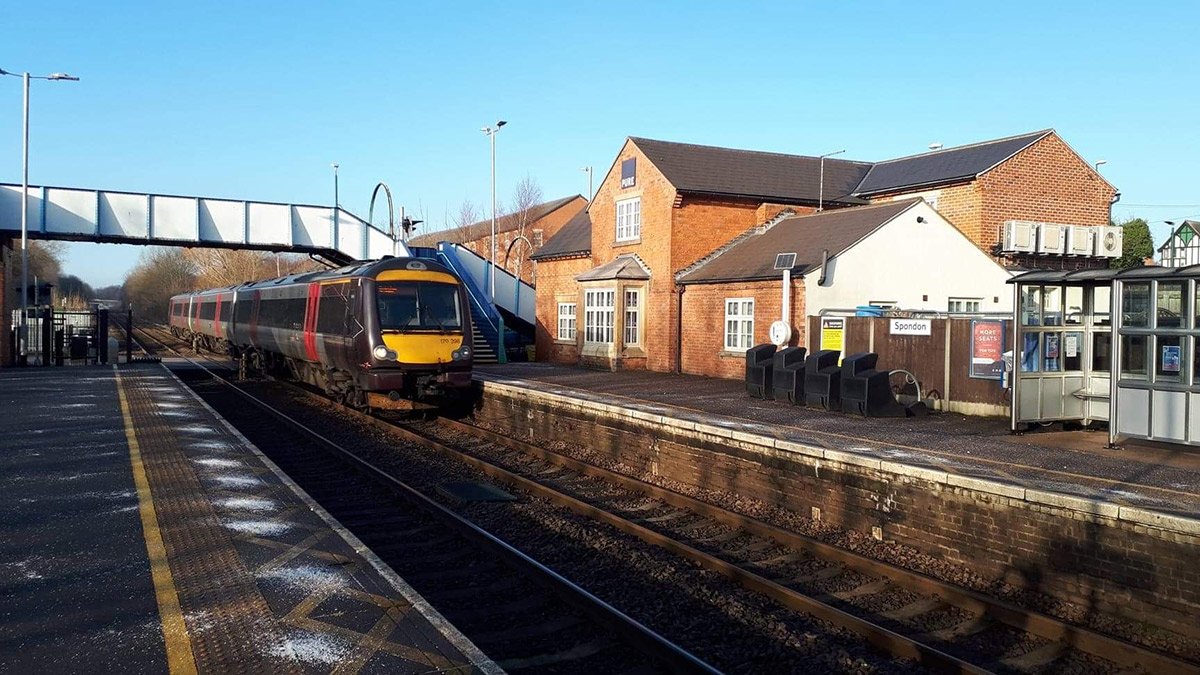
xmin=131 ymin=324 xmax=1196 ymax=673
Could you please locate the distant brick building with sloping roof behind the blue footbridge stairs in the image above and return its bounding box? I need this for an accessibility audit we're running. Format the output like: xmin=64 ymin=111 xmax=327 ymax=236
xmin=407 ymin=195 xmax=588 ymax=283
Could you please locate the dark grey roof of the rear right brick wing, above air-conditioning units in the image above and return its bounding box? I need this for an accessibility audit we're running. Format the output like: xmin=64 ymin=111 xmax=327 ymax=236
xmin=854 ymin=129 xmax=1054 ymax=195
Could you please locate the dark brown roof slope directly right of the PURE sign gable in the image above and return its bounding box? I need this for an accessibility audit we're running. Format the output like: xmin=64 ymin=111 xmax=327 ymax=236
xmin=630 ymin=137 xmax=871 ymax=204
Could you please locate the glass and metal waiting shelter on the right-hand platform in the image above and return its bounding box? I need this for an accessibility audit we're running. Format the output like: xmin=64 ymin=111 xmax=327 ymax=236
xmin=1009 ymin=265 xmax=1200 ymax=444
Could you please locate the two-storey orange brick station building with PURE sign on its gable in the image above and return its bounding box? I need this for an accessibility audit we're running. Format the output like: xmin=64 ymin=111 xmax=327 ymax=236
xmin=532 ymin=130 xmax=1116 ymax=376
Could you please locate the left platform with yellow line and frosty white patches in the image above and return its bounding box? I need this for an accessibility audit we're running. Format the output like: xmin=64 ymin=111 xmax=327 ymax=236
xmin=0 ymin=364 xmax=499 ymax=673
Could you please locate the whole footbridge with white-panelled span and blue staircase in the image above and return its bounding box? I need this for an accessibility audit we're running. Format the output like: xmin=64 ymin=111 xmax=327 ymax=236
xmin=0 ymin=183 xmax=536 ymax=362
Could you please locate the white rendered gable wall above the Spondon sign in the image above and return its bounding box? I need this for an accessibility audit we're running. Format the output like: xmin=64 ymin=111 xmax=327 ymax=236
xmin=804 ymin=202 xmax=1013 ymax=316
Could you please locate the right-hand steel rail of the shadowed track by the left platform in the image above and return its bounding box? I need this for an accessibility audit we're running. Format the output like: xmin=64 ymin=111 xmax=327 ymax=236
xmin=130 ymin=329 xmax=720 ymax=674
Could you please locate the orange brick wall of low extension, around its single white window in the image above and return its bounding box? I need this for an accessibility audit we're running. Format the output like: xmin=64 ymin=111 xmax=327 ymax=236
xmin=682 ymin=277 xmax=805 ymax=380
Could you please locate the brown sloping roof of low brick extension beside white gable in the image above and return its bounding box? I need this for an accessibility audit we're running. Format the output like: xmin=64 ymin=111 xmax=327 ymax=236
xmin=677 ymin=197 xmax=922 ymax=283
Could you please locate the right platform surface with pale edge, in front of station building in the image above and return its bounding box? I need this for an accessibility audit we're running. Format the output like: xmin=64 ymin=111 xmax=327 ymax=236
xmin=475 ymin=363 xmax=1200 ymax=516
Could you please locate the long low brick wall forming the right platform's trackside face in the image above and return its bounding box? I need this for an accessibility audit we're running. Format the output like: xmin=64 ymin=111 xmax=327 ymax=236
xmin=476 ymin=384 xmax=1200 ymax=635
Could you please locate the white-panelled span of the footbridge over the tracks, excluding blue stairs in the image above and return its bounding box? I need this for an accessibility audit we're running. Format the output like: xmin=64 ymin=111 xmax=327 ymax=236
xmin=0 ymin=184 xmax=408 ymax=263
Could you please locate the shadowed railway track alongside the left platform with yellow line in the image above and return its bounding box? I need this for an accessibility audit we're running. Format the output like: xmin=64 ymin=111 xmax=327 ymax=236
xmin=135 ymin=330 xmax=715 ymax=673
